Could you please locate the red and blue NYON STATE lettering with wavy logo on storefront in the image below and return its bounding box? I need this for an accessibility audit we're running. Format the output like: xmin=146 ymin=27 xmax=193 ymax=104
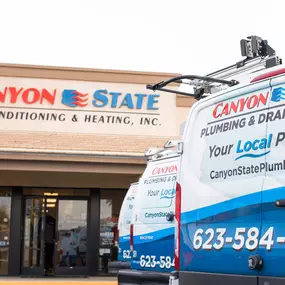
xmin=0 ymin=86 xmax=160 ymax=111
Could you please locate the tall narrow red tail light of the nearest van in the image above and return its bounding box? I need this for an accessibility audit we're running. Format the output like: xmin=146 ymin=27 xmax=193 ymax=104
xmin=174 ymin=182 xmax=181 ymax=270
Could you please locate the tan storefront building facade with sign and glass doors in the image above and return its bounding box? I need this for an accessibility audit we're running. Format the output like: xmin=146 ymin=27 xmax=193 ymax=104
xmin=0 ymin=64 xmax=193 ymax=276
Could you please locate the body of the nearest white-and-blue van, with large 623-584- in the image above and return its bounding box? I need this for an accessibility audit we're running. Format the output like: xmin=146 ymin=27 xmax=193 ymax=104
xmin=173 ymin=66 xmax=285 ymax=285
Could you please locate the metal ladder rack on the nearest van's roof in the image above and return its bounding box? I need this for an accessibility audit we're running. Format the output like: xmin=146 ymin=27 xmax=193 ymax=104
xmin=146 ymin=36 xmax=282 ymax=100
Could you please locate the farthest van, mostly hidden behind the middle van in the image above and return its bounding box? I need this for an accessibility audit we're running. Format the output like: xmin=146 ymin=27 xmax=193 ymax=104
xmin=108 ymin=182 xmax=138 ymax=274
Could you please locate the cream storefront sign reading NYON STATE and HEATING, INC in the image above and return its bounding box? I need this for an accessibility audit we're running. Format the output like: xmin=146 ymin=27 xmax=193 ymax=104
xmin=0 ymin=77 xmax=176 ymax=136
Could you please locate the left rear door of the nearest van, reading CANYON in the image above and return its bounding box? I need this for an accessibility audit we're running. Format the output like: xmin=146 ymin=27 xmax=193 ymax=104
xmin=178 ymin=81 xmax=271 ymax=276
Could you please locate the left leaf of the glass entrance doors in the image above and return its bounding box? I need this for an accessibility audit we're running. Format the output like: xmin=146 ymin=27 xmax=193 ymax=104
xmin=22 ymin=197 xmax=46 ymax=276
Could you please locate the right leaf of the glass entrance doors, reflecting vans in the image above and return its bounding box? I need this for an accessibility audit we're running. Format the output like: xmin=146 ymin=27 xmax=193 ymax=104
xmin=55 ymin=199 xmax=88 ymax=275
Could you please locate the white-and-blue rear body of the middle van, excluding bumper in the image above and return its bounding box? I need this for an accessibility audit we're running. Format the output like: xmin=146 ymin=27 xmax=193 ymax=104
xmin=131 ymin=150 xmax=180 ymax=272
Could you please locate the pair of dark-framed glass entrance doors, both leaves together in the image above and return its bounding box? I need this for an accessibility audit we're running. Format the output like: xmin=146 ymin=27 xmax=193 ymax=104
xmin=22 ymin=196 xmax=88 ymax=276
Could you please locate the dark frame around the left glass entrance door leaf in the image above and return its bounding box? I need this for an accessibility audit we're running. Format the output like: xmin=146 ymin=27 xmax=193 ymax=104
xmin=20 ymin=195 xmax=46 ymax=276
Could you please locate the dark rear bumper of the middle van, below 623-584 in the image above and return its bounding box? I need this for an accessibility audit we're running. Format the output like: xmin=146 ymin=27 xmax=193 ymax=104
xmin=117 ymin=269 xmax=170 ymax=285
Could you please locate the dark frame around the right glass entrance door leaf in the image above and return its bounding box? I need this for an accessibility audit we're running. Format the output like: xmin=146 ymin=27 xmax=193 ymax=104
xmin=54 ymin=196 xmax=90 ymax=276
